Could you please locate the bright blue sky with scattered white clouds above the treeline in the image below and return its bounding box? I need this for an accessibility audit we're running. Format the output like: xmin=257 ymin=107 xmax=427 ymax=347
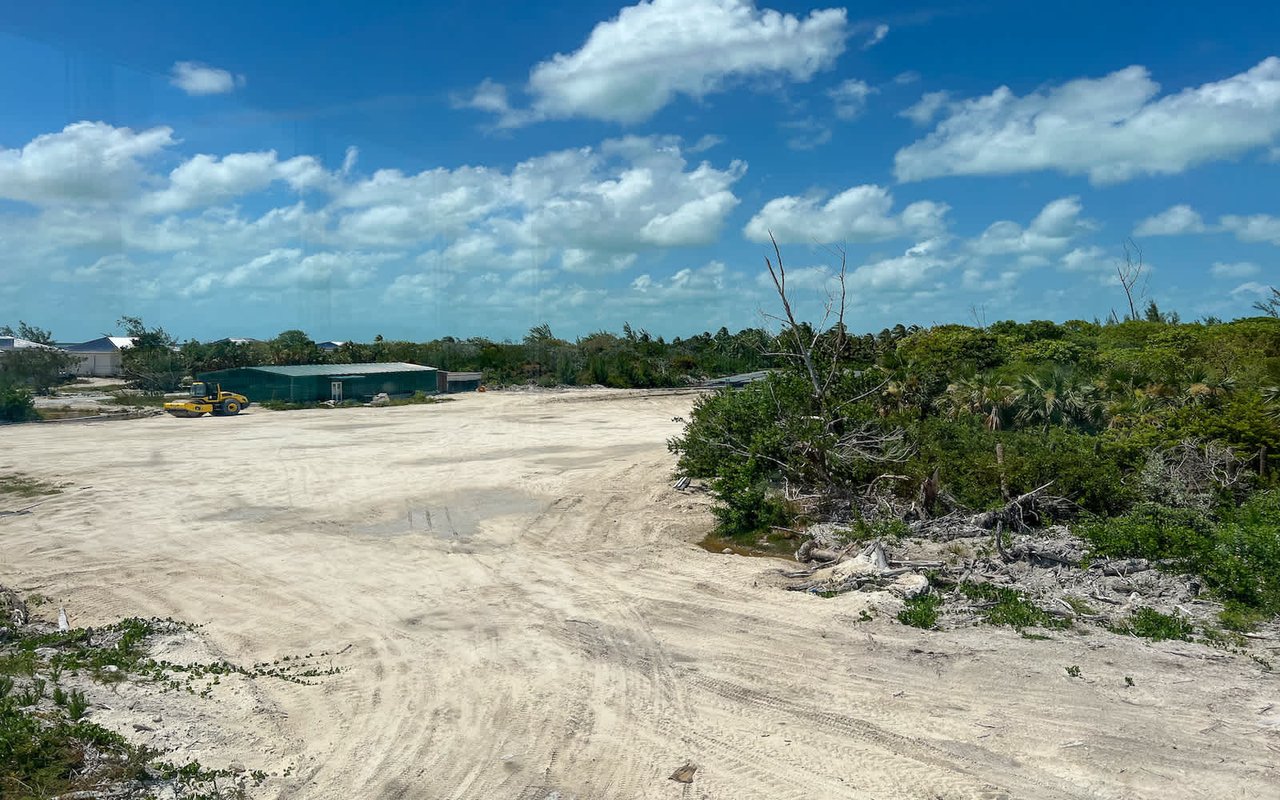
xmin=0 ymin=0 xmax=1280 ymax=340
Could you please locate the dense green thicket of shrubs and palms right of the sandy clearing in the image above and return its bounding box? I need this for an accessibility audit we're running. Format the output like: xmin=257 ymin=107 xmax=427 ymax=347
xmin=669 ymin=288 xmax=1280 ymax=628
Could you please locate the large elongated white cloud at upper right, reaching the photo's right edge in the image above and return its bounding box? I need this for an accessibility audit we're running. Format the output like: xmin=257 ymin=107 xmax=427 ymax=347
xmin=895 ymin=58 xmax=1280 ymax=184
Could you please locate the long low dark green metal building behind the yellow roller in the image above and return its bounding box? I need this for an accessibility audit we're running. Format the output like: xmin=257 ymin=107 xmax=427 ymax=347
xmin=196 ymin=362 xmax=439 ymax=403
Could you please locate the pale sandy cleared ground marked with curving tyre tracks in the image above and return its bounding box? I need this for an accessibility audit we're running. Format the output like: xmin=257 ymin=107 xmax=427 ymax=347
xmin=0 ymin=392 xmax=1280 ymax=800
